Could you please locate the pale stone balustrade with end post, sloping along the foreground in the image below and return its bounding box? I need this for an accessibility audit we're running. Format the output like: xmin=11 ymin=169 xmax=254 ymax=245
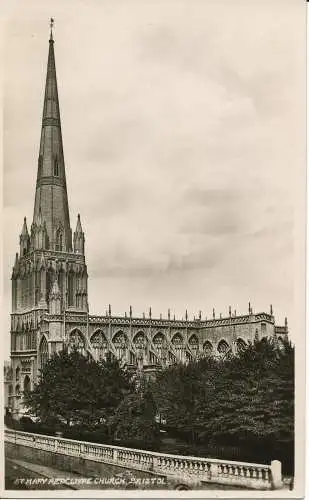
xmin=5 ymin=429 xmax=282 ymax=489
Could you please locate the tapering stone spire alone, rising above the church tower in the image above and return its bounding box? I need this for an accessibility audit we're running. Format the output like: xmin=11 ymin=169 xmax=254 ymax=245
xmin=33 ymin=19 xmax=72 ymax=252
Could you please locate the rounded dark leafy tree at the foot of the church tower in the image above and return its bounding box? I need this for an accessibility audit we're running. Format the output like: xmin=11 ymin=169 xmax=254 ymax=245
xmin=25 ymin=349 xmax=132 ymax=429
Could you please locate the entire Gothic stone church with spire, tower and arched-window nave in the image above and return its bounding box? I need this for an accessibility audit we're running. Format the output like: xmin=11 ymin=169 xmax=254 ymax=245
xmin=5 ymin=26 xmax=288 ymax=415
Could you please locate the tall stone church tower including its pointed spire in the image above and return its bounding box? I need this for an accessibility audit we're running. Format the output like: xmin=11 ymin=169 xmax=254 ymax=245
xmin=11 ymin=23 xmax=88 ymax=414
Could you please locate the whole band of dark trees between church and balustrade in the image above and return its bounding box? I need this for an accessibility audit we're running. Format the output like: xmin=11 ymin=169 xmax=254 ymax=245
xmin=17 ymin=340 xmax=294 ymax=474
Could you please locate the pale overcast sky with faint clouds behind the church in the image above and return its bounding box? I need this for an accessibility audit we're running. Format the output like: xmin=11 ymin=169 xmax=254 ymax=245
xmin=4 ymin=0 xmax=305 ymax=360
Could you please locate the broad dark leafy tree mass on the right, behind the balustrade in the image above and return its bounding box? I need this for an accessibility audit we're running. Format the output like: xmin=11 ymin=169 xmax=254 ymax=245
xmin=149 ymin=340 xmax=294 ymax=470
